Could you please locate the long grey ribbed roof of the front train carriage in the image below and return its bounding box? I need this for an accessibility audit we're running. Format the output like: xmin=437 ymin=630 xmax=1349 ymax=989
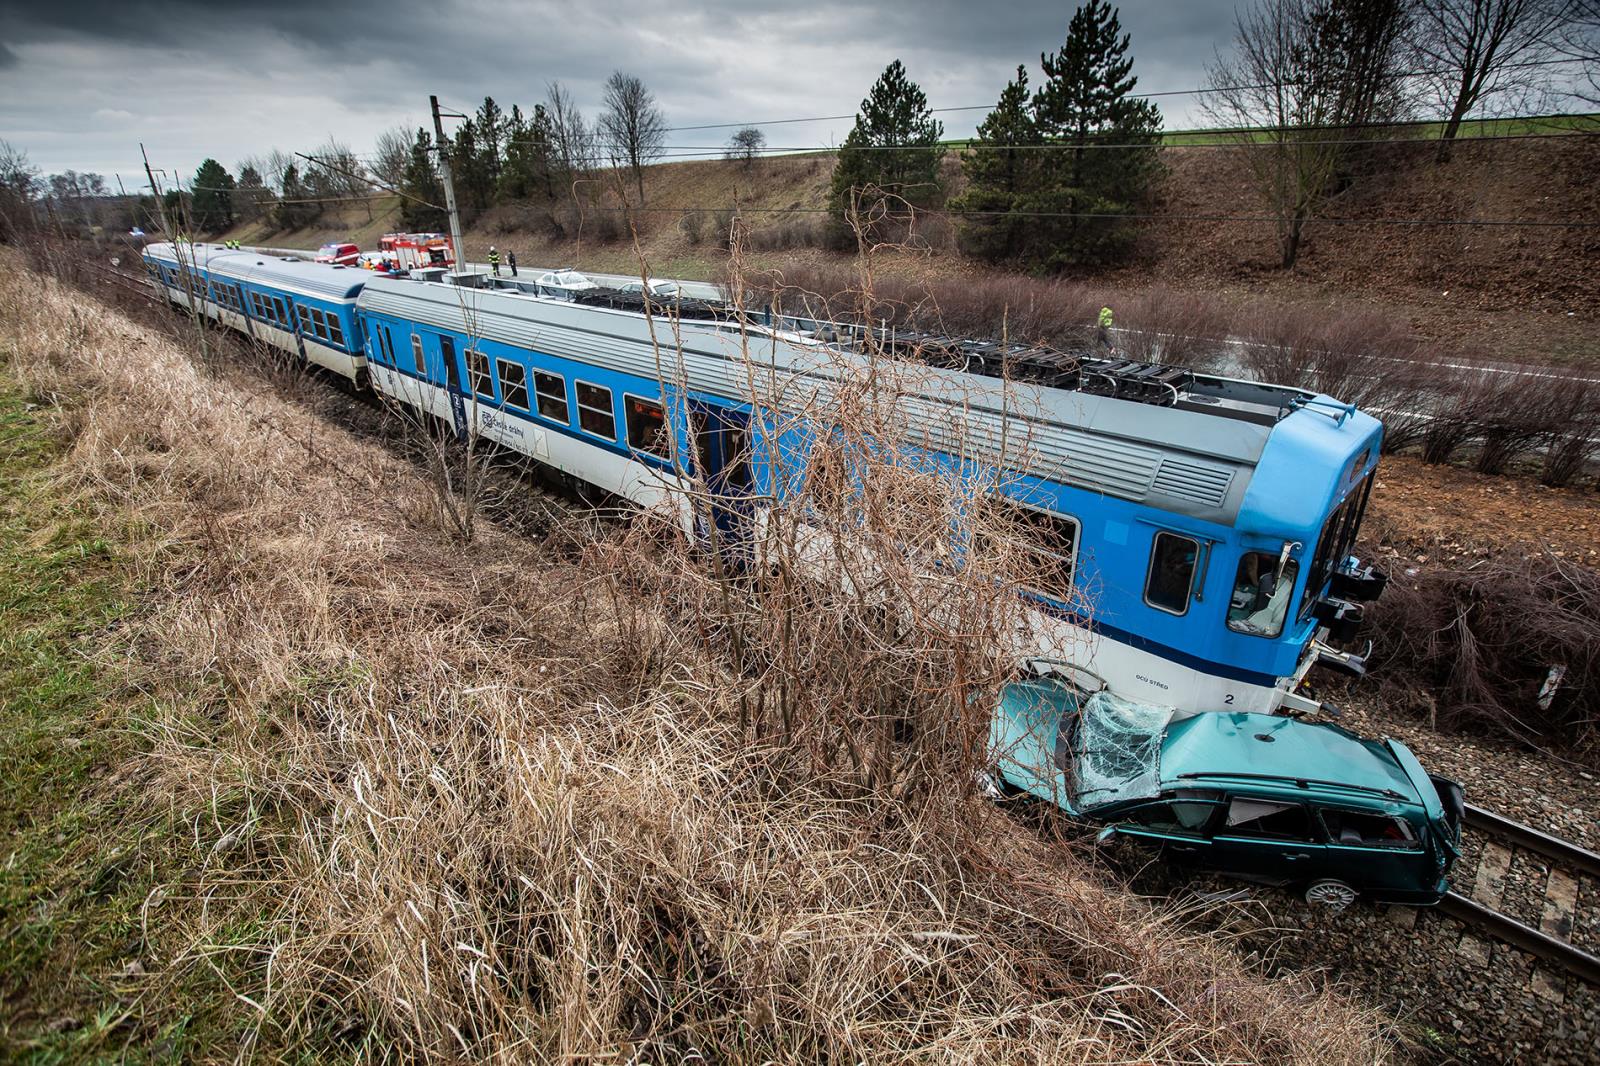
xmin=357 ymin=277 xmax=1379 ymax=524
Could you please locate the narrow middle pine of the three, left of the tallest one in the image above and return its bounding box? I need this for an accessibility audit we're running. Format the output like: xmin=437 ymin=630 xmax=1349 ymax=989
xmin=950 ymin=66 xmax=1042 ymax=261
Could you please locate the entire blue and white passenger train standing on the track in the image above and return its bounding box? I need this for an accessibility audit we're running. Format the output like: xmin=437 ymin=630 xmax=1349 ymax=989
xmin=146 ymin=236 xmax=1384 ymax=712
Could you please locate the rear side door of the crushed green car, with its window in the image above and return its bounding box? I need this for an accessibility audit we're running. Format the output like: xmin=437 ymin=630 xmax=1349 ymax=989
xmin=1206 ymin=792 xmax=1326 ymax=884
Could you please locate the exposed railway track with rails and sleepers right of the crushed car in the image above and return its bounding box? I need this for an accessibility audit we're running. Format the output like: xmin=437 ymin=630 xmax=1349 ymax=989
xmin=1438 ymin=804 xmax=1600 ymax=986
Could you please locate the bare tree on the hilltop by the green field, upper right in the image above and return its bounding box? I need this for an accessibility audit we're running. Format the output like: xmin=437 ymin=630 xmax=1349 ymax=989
xmin=1411 ymin=0 xmax=1565 ymax=163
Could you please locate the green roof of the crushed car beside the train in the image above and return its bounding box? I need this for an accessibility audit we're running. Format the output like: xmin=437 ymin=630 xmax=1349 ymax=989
xmin=1160 ymin=711 xmax=1422 ymax=805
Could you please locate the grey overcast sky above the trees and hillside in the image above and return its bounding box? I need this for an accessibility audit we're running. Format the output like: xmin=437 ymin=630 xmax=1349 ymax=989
xmin=0 ymin=0 xmax=1234 ymax=189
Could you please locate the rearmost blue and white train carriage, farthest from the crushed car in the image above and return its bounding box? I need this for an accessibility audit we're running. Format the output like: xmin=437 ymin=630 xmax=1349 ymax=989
xmin=144 ymin=242 xmax=368 ymax=384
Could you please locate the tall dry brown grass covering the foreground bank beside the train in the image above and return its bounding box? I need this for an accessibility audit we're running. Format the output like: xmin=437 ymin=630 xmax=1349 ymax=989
xmin=0 ymin=252 xmax=1387 ymax=1063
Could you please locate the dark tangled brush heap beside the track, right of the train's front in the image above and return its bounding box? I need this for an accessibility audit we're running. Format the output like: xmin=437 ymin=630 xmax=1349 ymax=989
xmin=1370 ymin=555 xmax=1600 ymax=760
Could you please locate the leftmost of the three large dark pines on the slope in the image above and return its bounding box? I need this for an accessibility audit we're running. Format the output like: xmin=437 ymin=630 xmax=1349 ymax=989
xmin=830 ymin=59 xmax=944 ymax=228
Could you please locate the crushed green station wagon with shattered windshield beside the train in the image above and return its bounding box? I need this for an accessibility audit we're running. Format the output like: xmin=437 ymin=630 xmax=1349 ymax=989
xmin=990 ymin=674 xmax=1464 ymax=909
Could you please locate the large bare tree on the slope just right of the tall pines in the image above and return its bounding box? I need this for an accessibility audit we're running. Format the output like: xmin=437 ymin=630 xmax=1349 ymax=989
xmin=1203 ymin=0 xmax=1406 ymax=269
